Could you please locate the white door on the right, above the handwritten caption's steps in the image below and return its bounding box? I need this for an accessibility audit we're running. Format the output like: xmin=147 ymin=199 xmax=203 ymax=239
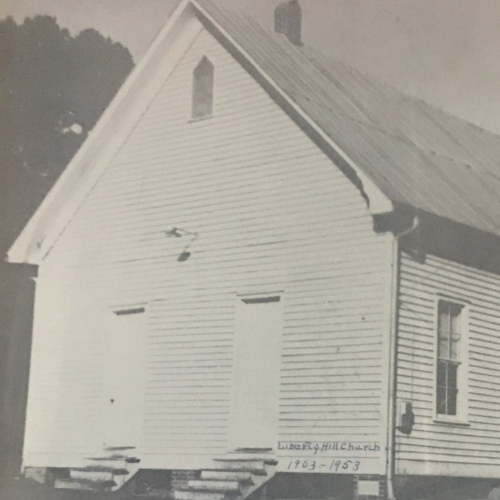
xmin=230 ymin=296 xmax=283 ymax=449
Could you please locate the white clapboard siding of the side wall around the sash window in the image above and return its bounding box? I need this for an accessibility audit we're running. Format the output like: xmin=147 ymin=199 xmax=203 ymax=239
xmin=397 ymin=253 xmax=500 ymax=477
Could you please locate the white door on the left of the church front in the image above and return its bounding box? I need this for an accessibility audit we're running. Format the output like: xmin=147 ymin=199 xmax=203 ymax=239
xmin=105 ymin=307 xmax=147 ymax=447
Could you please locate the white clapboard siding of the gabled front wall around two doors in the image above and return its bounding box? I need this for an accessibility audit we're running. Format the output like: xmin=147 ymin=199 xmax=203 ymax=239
xmin=25 ymin=28 xmax=390 ymax=467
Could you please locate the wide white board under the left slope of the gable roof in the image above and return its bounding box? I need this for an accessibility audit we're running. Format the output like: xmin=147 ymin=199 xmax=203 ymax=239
xmin=7 ymin=0 xmax=203 ymax=264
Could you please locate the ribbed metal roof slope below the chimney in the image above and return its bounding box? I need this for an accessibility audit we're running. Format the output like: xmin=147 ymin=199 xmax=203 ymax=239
xmin=198 ymin=0 xmax=500 ymax=234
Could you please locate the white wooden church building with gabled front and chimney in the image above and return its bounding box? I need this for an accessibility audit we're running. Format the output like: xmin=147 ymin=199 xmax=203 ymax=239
xmin=8 ymin=0 xmax=500 ymax=500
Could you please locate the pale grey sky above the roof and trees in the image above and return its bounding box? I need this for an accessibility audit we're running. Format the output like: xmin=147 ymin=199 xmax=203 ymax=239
xmin=0 ymin=0 xmax=500 ymax=134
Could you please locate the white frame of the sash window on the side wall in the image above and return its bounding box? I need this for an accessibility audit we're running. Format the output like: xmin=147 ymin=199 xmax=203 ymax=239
xmin=432 ymin=294 xmax=469 ymax=425
